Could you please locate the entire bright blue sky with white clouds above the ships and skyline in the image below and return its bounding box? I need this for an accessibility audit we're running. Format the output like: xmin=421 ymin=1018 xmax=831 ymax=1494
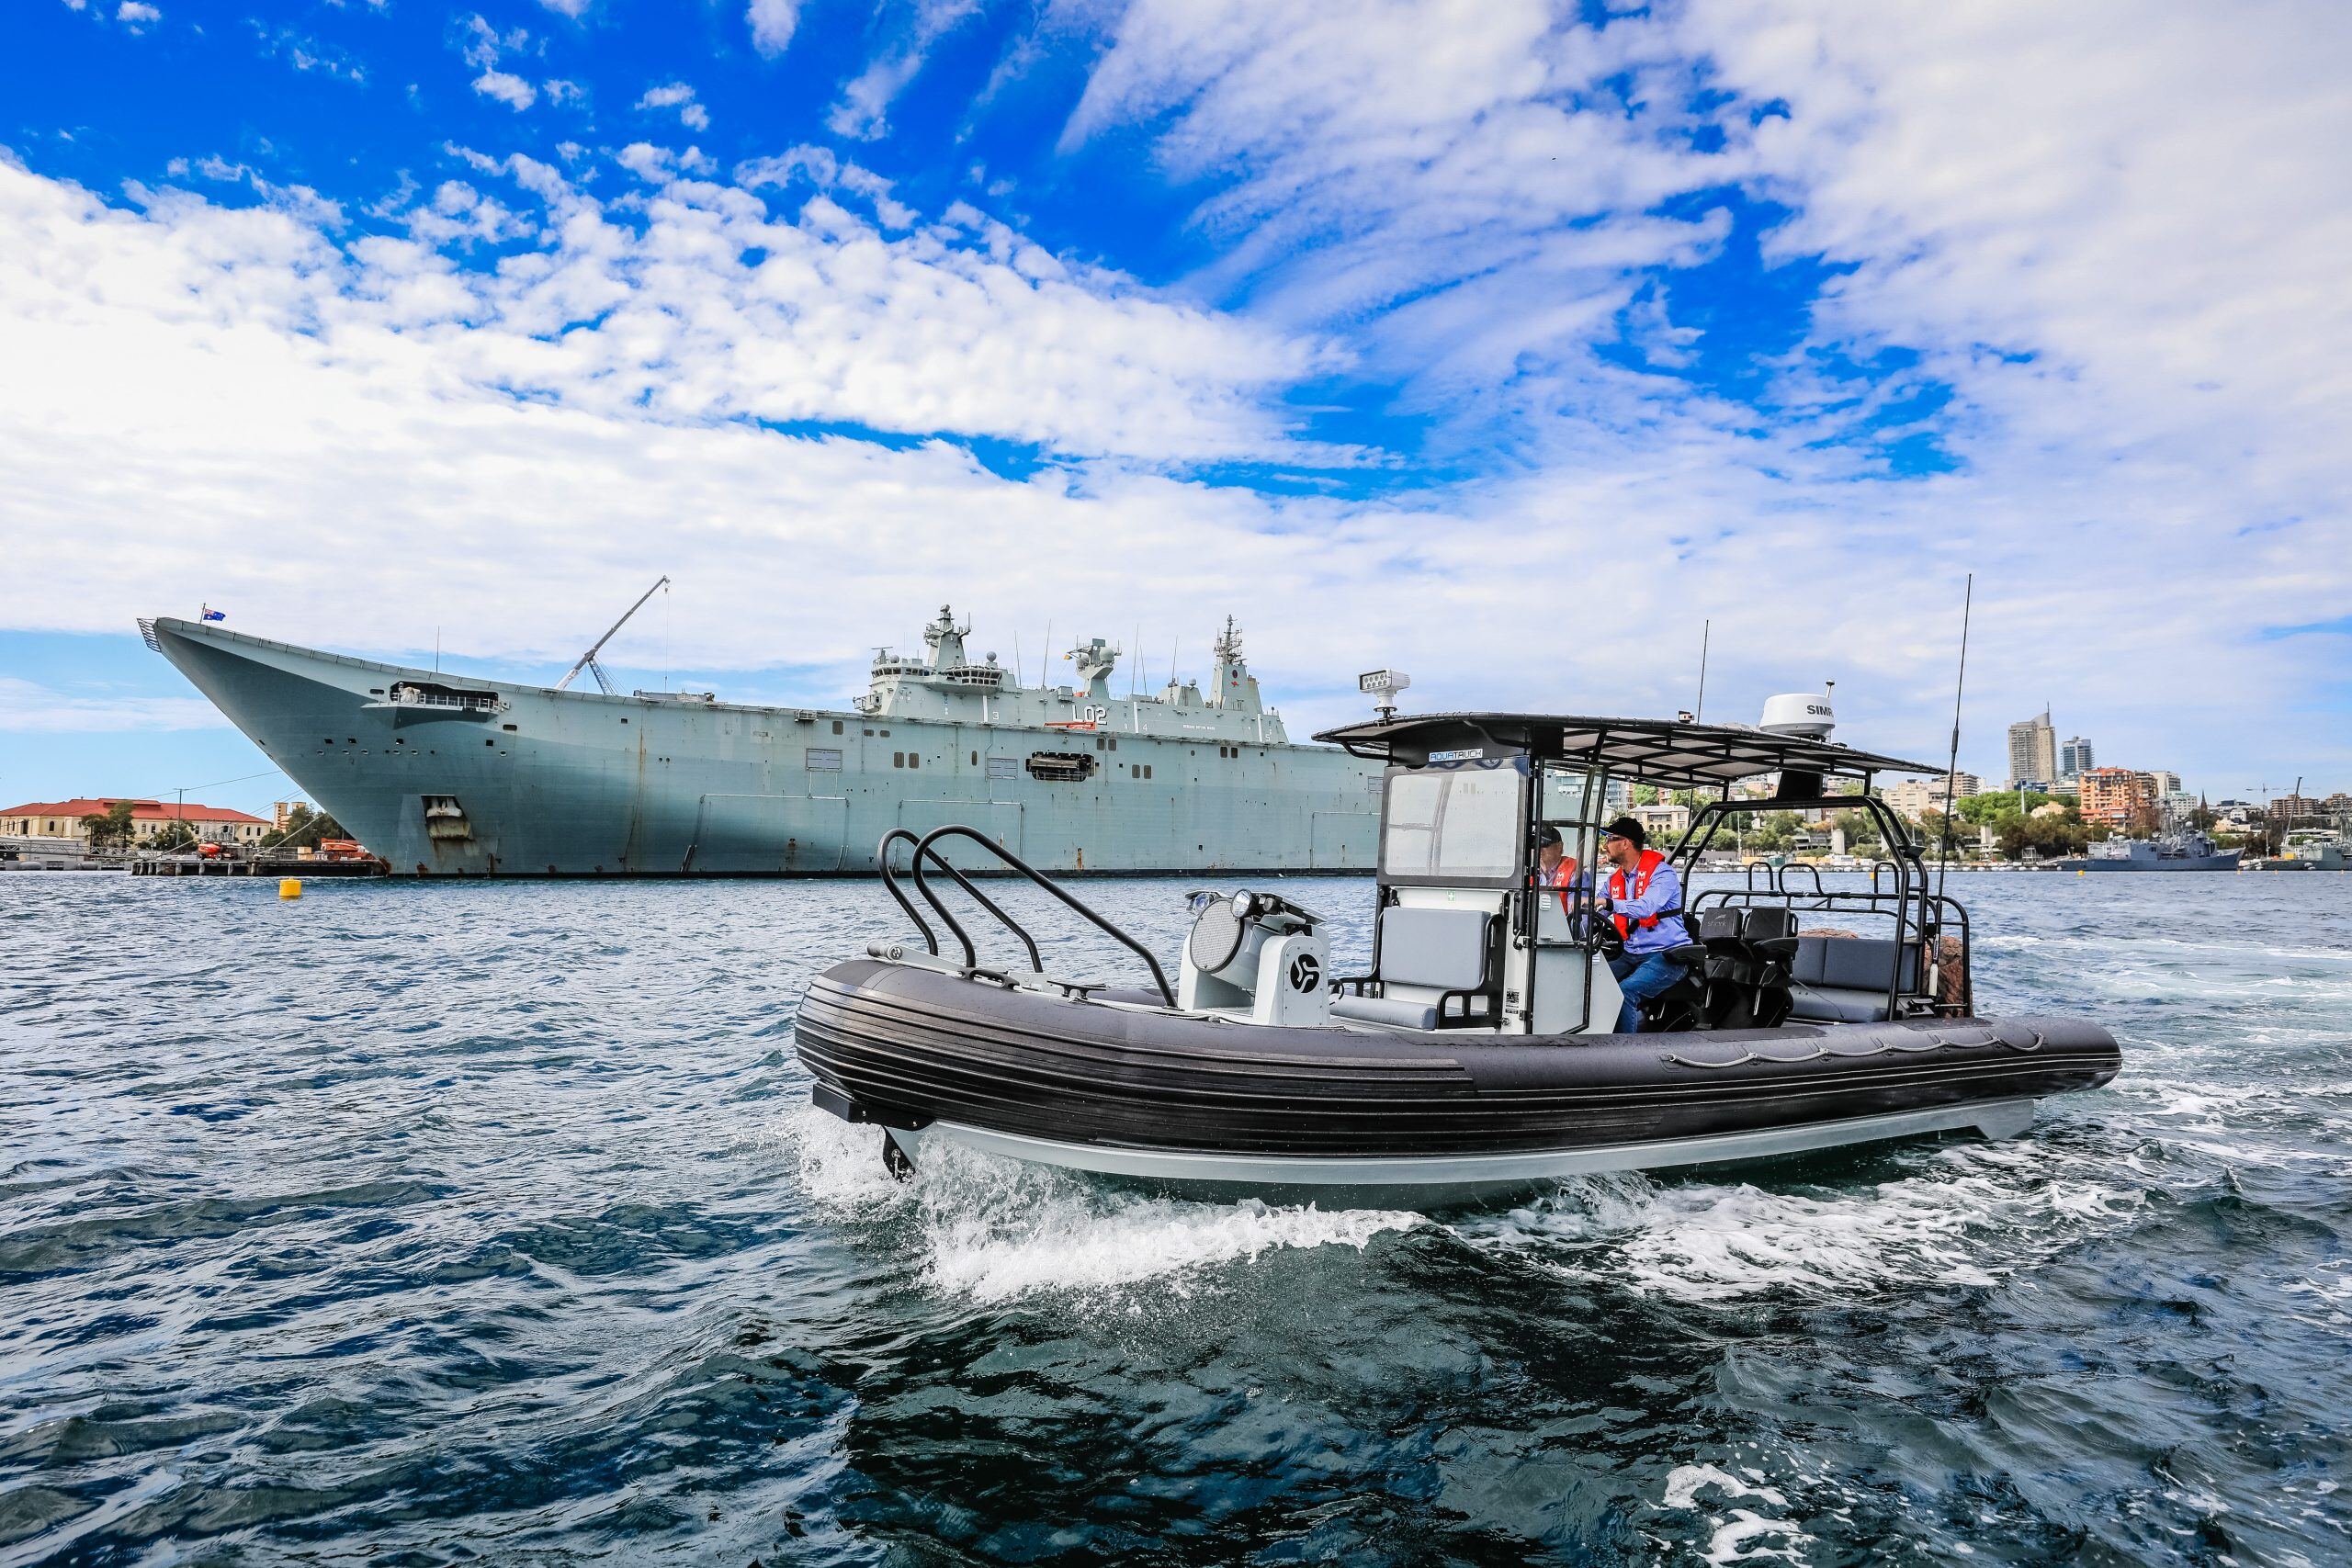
xmin=0 ymin=0 xmax=2352 ymax=807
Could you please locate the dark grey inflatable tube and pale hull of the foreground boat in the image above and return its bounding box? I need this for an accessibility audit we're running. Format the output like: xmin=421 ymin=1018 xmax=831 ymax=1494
xmin=793 ymin=959 xmax=2121 ymax=1203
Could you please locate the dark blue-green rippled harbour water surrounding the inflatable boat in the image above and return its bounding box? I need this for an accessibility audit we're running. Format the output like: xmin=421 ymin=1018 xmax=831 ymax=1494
xmin=0 ymin=874 xmax=2352 ymax=1568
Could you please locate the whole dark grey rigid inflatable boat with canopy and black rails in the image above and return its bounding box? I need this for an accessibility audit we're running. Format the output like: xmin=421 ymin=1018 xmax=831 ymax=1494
xmin=797 ymin=698 xmax=2121 ymax=1206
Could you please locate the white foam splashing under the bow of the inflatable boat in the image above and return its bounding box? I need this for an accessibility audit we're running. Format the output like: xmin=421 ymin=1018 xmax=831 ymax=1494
xmin=786 ymin=1110 xmax=1423 ymax=1303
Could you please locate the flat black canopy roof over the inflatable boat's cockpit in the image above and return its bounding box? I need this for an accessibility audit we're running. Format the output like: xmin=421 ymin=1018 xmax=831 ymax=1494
xmin=1315 ymin=712 xmax=1943 ymax=790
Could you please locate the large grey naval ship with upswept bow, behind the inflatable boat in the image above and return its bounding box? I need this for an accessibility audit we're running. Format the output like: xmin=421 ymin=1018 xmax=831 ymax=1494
xmin=139 ymin=609 xmax=1378 ymax=877
